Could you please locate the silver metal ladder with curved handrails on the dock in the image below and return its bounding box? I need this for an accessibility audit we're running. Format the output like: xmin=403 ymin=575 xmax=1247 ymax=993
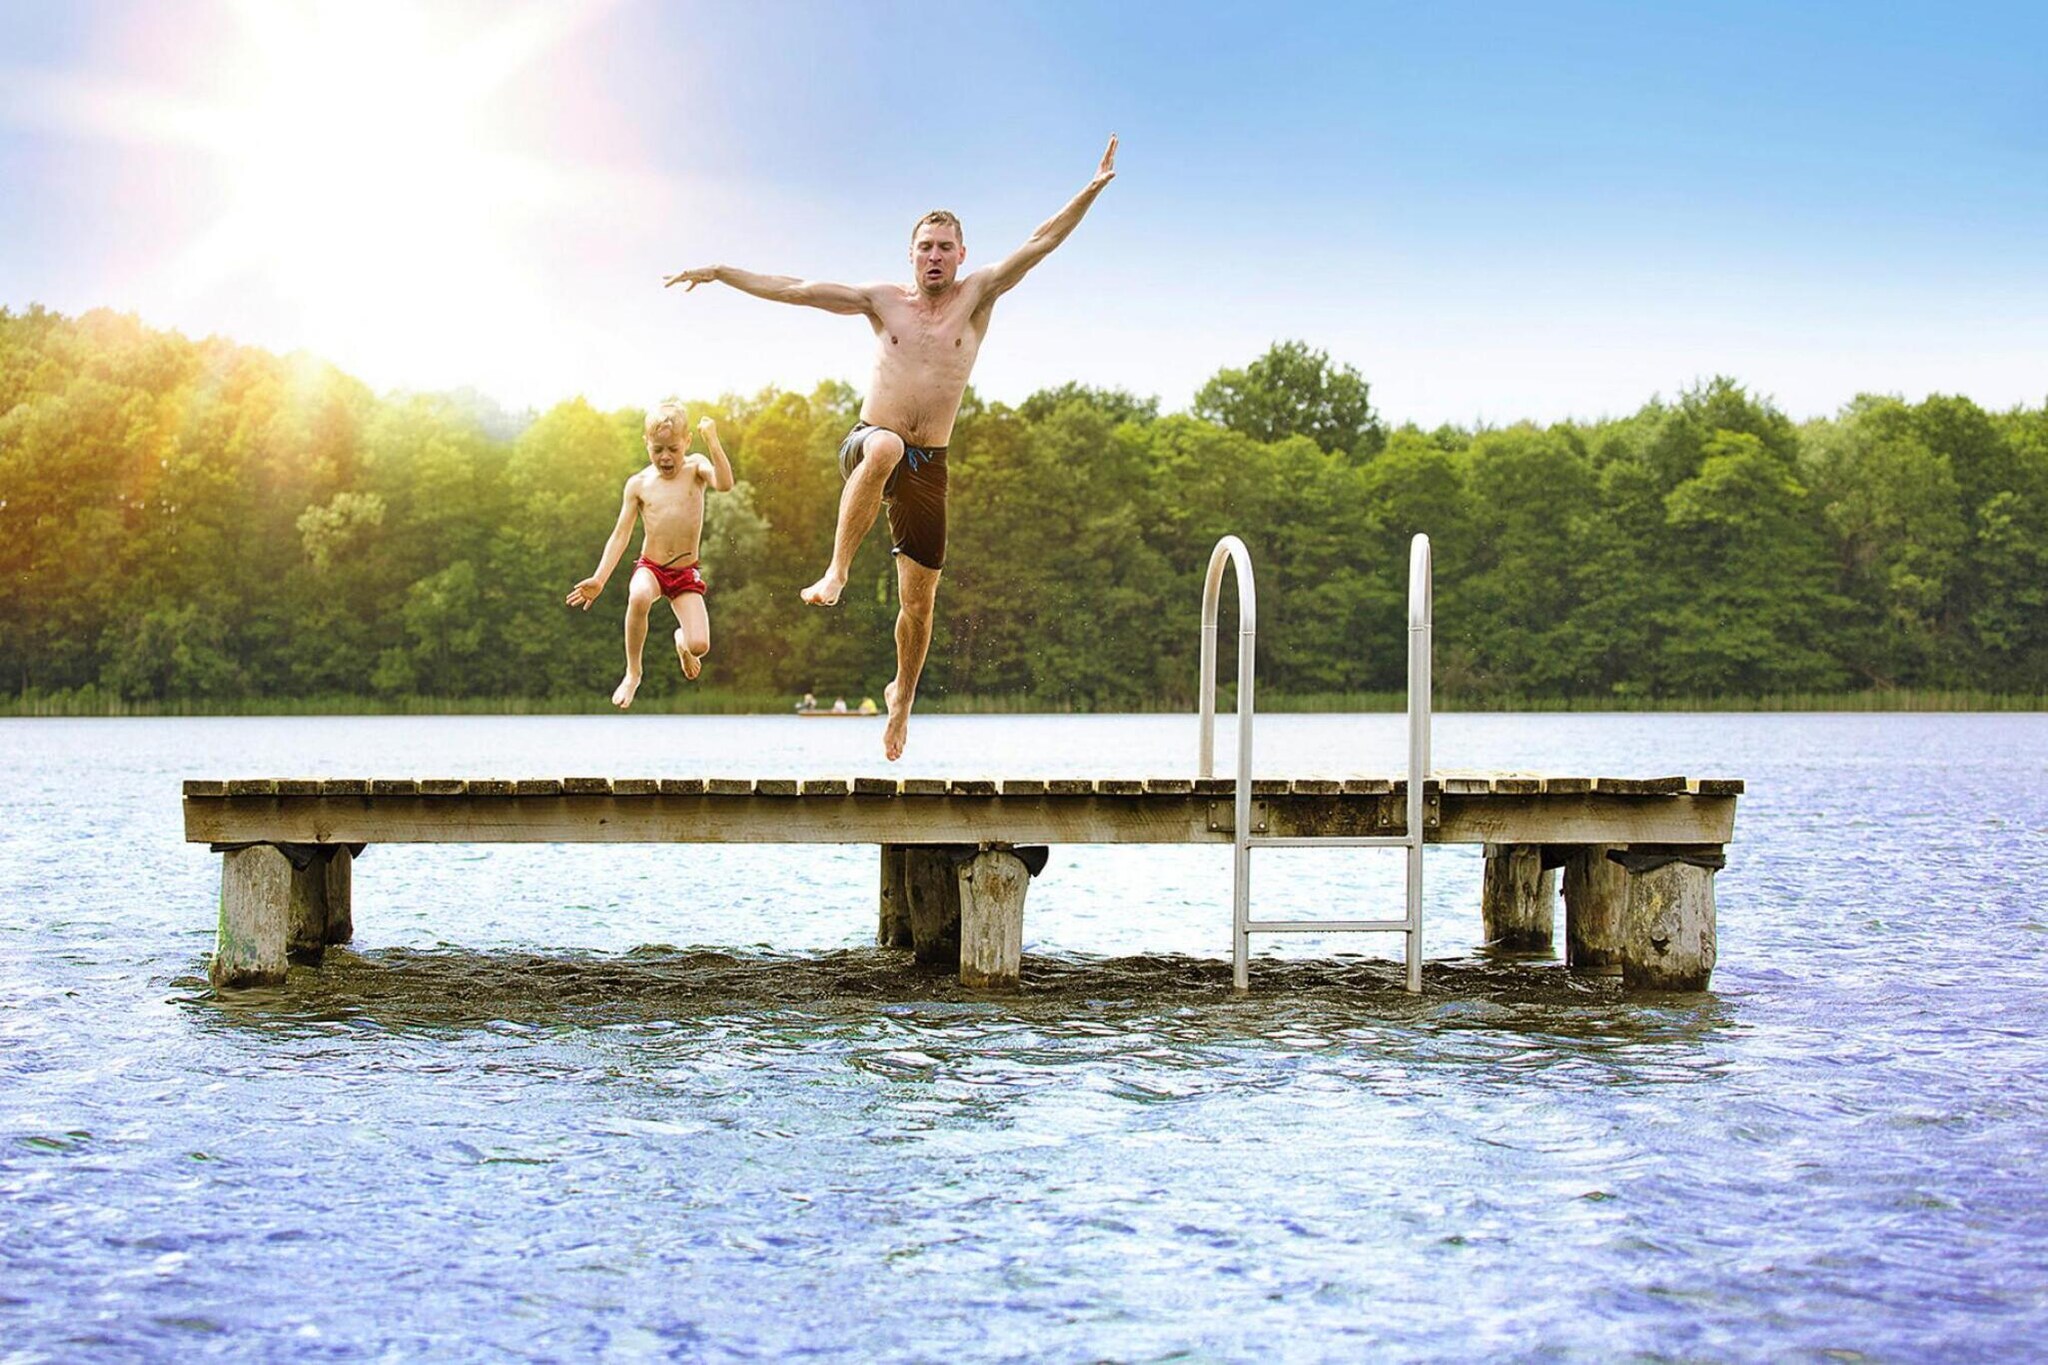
xmin=1198 ymin=534 xmax=1432 ymax=993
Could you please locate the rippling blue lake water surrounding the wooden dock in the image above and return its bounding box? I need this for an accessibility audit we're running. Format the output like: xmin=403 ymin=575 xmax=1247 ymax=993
xmin=0 ymin=714 xmax=2048 ymax=1363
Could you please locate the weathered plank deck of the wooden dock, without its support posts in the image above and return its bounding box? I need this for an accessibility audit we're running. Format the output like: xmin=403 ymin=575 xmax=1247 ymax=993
xmin=184 ymin=776 xmax=1743 ymax=845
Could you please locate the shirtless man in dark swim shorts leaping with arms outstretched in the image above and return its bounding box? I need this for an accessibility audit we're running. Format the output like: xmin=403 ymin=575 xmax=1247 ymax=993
xmin=666 ymin=135 xmax=1116 ymax=759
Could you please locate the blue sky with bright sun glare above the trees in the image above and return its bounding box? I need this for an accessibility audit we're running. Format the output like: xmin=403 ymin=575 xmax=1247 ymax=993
xmin=0 ymin=0 xmax=2048 ymax=424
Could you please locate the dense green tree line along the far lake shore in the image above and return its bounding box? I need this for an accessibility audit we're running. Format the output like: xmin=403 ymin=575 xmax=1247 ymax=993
xmin=0 ymin=307 xmax=2048 ymax=710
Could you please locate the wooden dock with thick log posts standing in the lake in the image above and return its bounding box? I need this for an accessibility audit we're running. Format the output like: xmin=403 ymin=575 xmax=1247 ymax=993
xmin=184 ymin=774 xmax=1743 ymax=990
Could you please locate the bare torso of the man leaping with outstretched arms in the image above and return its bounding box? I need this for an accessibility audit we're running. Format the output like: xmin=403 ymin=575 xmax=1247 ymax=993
xmin=860 ymin=276 xmax=989 ymax=446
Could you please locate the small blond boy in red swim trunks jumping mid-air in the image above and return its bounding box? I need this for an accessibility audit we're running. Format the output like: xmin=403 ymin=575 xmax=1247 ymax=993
xmin=567 ymin=399 xmax=733 ymax=710
